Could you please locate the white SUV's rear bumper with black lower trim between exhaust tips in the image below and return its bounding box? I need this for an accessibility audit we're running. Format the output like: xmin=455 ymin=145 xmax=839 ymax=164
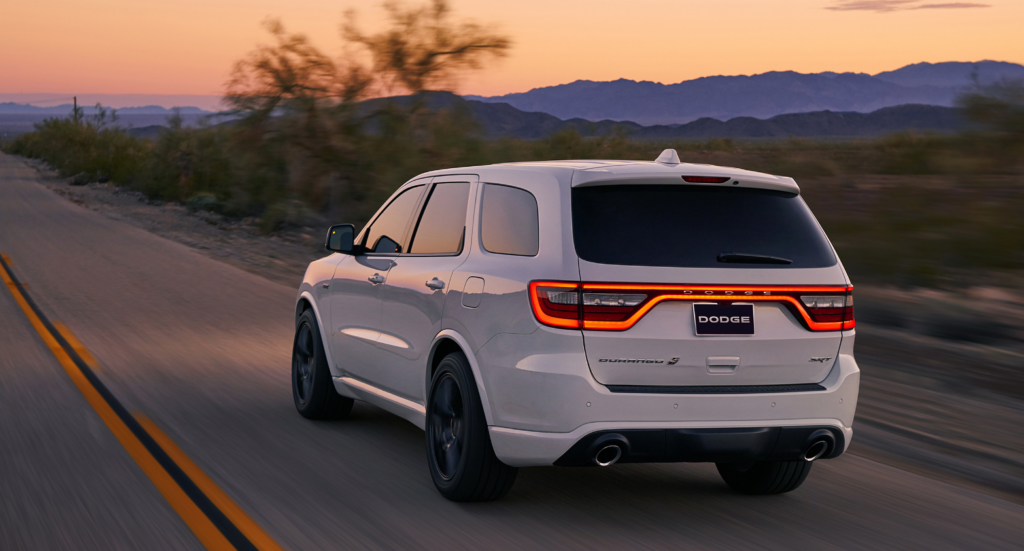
xmin=489 ymin=354 xmax=860 ymax=467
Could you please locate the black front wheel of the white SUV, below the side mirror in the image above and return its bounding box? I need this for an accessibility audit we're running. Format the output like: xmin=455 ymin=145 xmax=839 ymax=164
xmin=292 ymin=308 xmax=354 ymax=419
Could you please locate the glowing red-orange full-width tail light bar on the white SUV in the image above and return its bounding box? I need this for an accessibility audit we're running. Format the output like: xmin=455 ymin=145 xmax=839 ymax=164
xmin=529 ymin=282 xmax=856 ymax=331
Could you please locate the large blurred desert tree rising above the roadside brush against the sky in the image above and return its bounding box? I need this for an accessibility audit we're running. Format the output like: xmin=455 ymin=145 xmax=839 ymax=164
xmin=226 ymin=0 xmax=510 ymax=217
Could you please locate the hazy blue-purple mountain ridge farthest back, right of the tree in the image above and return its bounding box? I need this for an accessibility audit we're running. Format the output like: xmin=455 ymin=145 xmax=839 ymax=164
xmin=466 ymin=61 xmax=1024 ymax=125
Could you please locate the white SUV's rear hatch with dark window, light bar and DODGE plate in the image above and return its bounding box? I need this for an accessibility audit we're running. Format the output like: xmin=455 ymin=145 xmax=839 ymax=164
xmin=569 ymin=183 xmax=853 ymax=383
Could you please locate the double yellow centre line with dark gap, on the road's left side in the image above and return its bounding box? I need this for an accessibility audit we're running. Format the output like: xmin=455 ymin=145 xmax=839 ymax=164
xmin=0 ymin=255 xmax=282 ymax=551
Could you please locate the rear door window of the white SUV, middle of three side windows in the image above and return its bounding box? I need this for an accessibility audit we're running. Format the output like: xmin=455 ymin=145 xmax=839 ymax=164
xmin=409 ymin=182 xmax=469 ymax=254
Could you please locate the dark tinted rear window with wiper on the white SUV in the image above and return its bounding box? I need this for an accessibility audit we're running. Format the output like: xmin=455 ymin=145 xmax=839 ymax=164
xmin=572 ymin=185 xmax=837 ymax=268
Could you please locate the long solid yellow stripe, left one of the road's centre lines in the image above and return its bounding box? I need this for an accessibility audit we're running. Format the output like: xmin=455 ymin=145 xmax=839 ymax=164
xmin=0 ymin=259 xmax=241 ymax=551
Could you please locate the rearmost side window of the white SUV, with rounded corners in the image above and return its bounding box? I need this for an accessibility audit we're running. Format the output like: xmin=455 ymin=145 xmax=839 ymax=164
xmin=480 ymin=183 xmax=541 ymax=256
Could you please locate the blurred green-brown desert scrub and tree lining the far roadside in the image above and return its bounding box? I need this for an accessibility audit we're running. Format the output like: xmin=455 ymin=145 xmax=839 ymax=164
xmin=3 ymin=0 xmax=1024 ymax=289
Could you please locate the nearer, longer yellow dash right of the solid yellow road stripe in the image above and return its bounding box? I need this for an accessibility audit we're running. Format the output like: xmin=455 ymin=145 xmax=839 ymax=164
xmin=132 ymin=412 xmax=284 ymax=551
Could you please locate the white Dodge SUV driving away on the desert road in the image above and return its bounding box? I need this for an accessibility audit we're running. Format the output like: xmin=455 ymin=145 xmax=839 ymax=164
xmin=292 ymin=150 xmax=860 ymax=501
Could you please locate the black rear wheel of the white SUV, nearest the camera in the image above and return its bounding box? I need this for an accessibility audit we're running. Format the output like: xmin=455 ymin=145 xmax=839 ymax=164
xmin=426 ymin=352 xmax=518 ymax=502
